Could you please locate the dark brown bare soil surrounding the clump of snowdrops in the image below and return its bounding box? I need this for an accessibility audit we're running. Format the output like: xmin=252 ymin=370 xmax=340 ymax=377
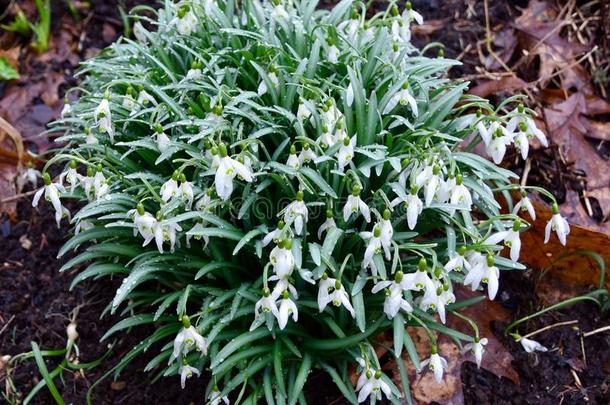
xmin=0 ymin=0 xmax=610 ymax=404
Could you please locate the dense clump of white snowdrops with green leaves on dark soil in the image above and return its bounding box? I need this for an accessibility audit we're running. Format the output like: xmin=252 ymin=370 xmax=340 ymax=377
xmin=34 ymin=0 xmax=569 ymax=404
